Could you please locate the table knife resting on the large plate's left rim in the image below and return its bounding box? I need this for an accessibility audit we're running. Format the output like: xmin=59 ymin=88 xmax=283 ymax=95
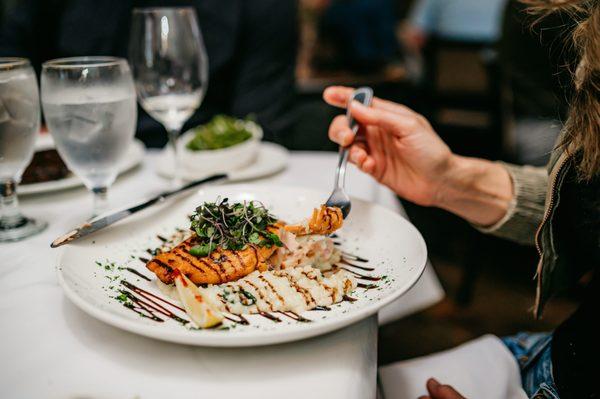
xmin=50 ymin=174 xmax=228 ymax=248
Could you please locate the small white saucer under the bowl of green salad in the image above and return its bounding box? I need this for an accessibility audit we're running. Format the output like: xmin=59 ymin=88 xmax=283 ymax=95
xmin=156 ymin=141 xmax=289 ymax=182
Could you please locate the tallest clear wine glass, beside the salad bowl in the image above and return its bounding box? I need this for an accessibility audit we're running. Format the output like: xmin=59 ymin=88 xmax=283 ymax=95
xmin=129 ymin=7 xmax=208 ymax=187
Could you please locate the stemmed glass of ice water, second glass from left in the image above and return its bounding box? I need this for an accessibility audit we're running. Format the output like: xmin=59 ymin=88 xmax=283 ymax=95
xmin=41 ymin=57 xmax=137 ymax=216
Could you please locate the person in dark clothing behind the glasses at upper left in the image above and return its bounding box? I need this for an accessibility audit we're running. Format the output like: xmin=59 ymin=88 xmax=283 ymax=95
xmin=0 ymin=0 xmax=297 ymax=147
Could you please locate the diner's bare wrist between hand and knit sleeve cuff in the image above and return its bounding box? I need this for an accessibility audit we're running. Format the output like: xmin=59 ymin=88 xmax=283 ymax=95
xmin=436 ymin=155 xmax=514 ymax=226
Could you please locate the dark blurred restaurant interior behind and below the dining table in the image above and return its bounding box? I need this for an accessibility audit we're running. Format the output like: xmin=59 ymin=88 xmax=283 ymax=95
xmin=0 ymin=0 xmax=577 ymax=364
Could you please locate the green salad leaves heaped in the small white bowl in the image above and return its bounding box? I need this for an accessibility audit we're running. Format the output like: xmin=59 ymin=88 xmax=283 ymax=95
xmin=186 ymin=115 xmax=258 ymax=151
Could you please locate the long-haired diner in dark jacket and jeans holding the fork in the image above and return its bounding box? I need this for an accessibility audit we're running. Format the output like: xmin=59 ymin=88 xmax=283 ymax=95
xmin=324 ymin=0 xmax=600 ymax=399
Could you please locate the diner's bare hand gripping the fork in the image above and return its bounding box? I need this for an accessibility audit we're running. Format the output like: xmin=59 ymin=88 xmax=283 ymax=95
xmin=323 ymin=87 xmax=454 ymax=206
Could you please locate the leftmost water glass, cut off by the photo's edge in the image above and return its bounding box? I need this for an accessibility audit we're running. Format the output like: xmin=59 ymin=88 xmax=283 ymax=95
xmin=0 ymin=58 xmax=47 ymax=242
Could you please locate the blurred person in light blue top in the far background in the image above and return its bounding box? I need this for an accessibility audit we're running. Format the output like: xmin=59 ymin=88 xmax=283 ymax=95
xmin=400 ymin=0 xmax=507 ymax=52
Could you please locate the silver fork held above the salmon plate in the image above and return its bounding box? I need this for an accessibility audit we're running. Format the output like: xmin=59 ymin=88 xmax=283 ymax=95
xmin=325 ymin=87 xmax=373 ymax=219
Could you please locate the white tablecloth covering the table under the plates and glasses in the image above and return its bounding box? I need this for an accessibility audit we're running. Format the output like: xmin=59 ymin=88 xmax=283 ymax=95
xmin=0 ymin=152 xmax=443 ymax=399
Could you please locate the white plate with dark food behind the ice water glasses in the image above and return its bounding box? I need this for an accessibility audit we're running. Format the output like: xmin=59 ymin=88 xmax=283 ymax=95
xmin=17 ymin=139 xmax=146 ymax=195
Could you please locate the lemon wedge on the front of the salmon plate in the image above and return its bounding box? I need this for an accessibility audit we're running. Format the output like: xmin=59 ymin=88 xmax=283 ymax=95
xmin=175 ymin=273 xmax=223 ymax=328
